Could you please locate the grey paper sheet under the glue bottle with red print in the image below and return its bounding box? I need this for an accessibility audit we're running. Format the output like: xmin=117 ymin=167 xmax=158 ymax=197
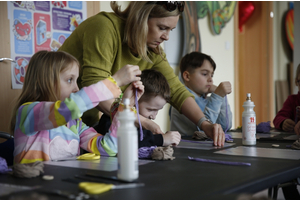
xmin=214 ymin=146 xmax=300 ymax=160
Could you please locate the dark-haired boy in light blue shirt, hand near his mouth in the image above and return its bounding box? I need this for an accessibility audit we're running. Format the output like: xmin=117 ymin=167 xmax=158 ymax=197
xmin=171 ymin=52 xmax=232 ymax=136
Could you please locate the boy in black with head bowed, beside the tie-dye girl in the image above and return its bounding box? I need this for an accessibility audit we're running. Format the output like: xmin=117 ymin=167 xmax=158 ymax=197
xmin=100 ymin=69 xmax=181 ymax=148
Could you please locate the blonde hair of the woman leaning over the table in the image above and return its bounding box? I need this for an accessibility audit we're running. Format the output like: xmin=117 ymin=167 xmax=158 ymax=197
xmin=110 ymin=1 xmax=180 ymax=63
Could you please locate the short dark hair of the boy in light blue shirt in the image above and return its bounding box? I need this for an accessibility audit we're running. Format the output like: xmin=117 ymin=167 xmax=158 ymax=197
xmin=180 ymin=51 xmax=217 ymax=76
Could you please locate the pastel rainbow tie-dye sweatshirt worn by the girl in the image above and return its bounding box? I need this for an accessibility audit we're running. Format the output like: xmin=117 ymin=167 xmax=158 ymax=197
xmin=14 ymin=78 xmax=121 ymax=164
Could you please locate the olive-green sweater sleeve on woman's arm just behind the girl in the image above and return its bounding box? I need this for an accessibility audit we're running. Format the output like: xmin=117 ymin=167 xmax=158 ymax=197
xmin=59 ymin=12 xmax=123 ymax=88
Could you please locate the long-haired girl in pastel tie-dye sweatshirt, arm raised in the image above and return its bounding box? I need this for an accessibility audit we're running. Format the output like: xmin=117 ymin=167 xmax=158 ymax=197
xmin=11 ymin=51 xmax=144 ymax=163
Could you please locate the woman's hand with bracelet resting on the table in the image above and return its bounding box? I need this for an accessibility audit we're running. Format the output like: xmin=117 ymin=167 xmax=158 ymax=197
xmin=200 ymin=121 xmax=225 ymax=147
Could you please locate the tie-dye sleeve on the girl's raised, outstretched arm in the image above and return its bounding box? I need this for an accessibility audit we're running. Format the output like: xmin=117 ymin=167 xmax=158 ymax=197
xmin=15 ymin=79 xmax=121 ymax=135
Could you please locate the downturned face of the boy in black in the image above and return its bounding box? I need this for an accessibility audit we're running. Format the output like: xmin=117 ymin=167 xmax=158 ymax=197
xmin=139 ymin=96 xmax=167 ymax=119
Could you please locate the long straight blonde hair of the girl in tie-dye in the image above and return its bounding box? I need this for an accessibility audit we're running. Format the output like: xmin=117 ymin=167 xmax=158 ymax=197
xmin=10 ymin=51 xmax=80 ymax=133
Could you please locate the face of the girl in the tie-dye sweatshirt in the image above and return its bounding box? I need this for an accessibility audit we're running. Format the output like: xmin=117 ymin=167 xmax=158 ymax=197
xmin=59 ymin=63 xmax=79 ymax=101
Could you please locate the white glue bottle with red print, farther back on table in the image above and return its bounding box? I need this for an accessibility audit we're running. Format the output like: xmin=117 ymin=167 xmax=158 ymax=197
xmin=242 ymin=93 xmax=256 ymax=145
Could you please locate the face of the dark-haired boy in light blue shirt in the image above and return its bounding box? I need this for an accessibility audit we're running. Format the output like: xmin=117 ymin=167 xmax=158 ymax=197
xmin=184 ymin=60 xmax=214 ymax=96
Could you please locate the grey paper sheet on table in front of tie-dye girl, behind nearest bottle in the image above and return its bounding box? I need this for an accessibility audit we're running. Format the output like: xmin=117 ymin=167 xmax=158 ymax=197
xmin=44 ymin=156 xmax=154 ymax=171
